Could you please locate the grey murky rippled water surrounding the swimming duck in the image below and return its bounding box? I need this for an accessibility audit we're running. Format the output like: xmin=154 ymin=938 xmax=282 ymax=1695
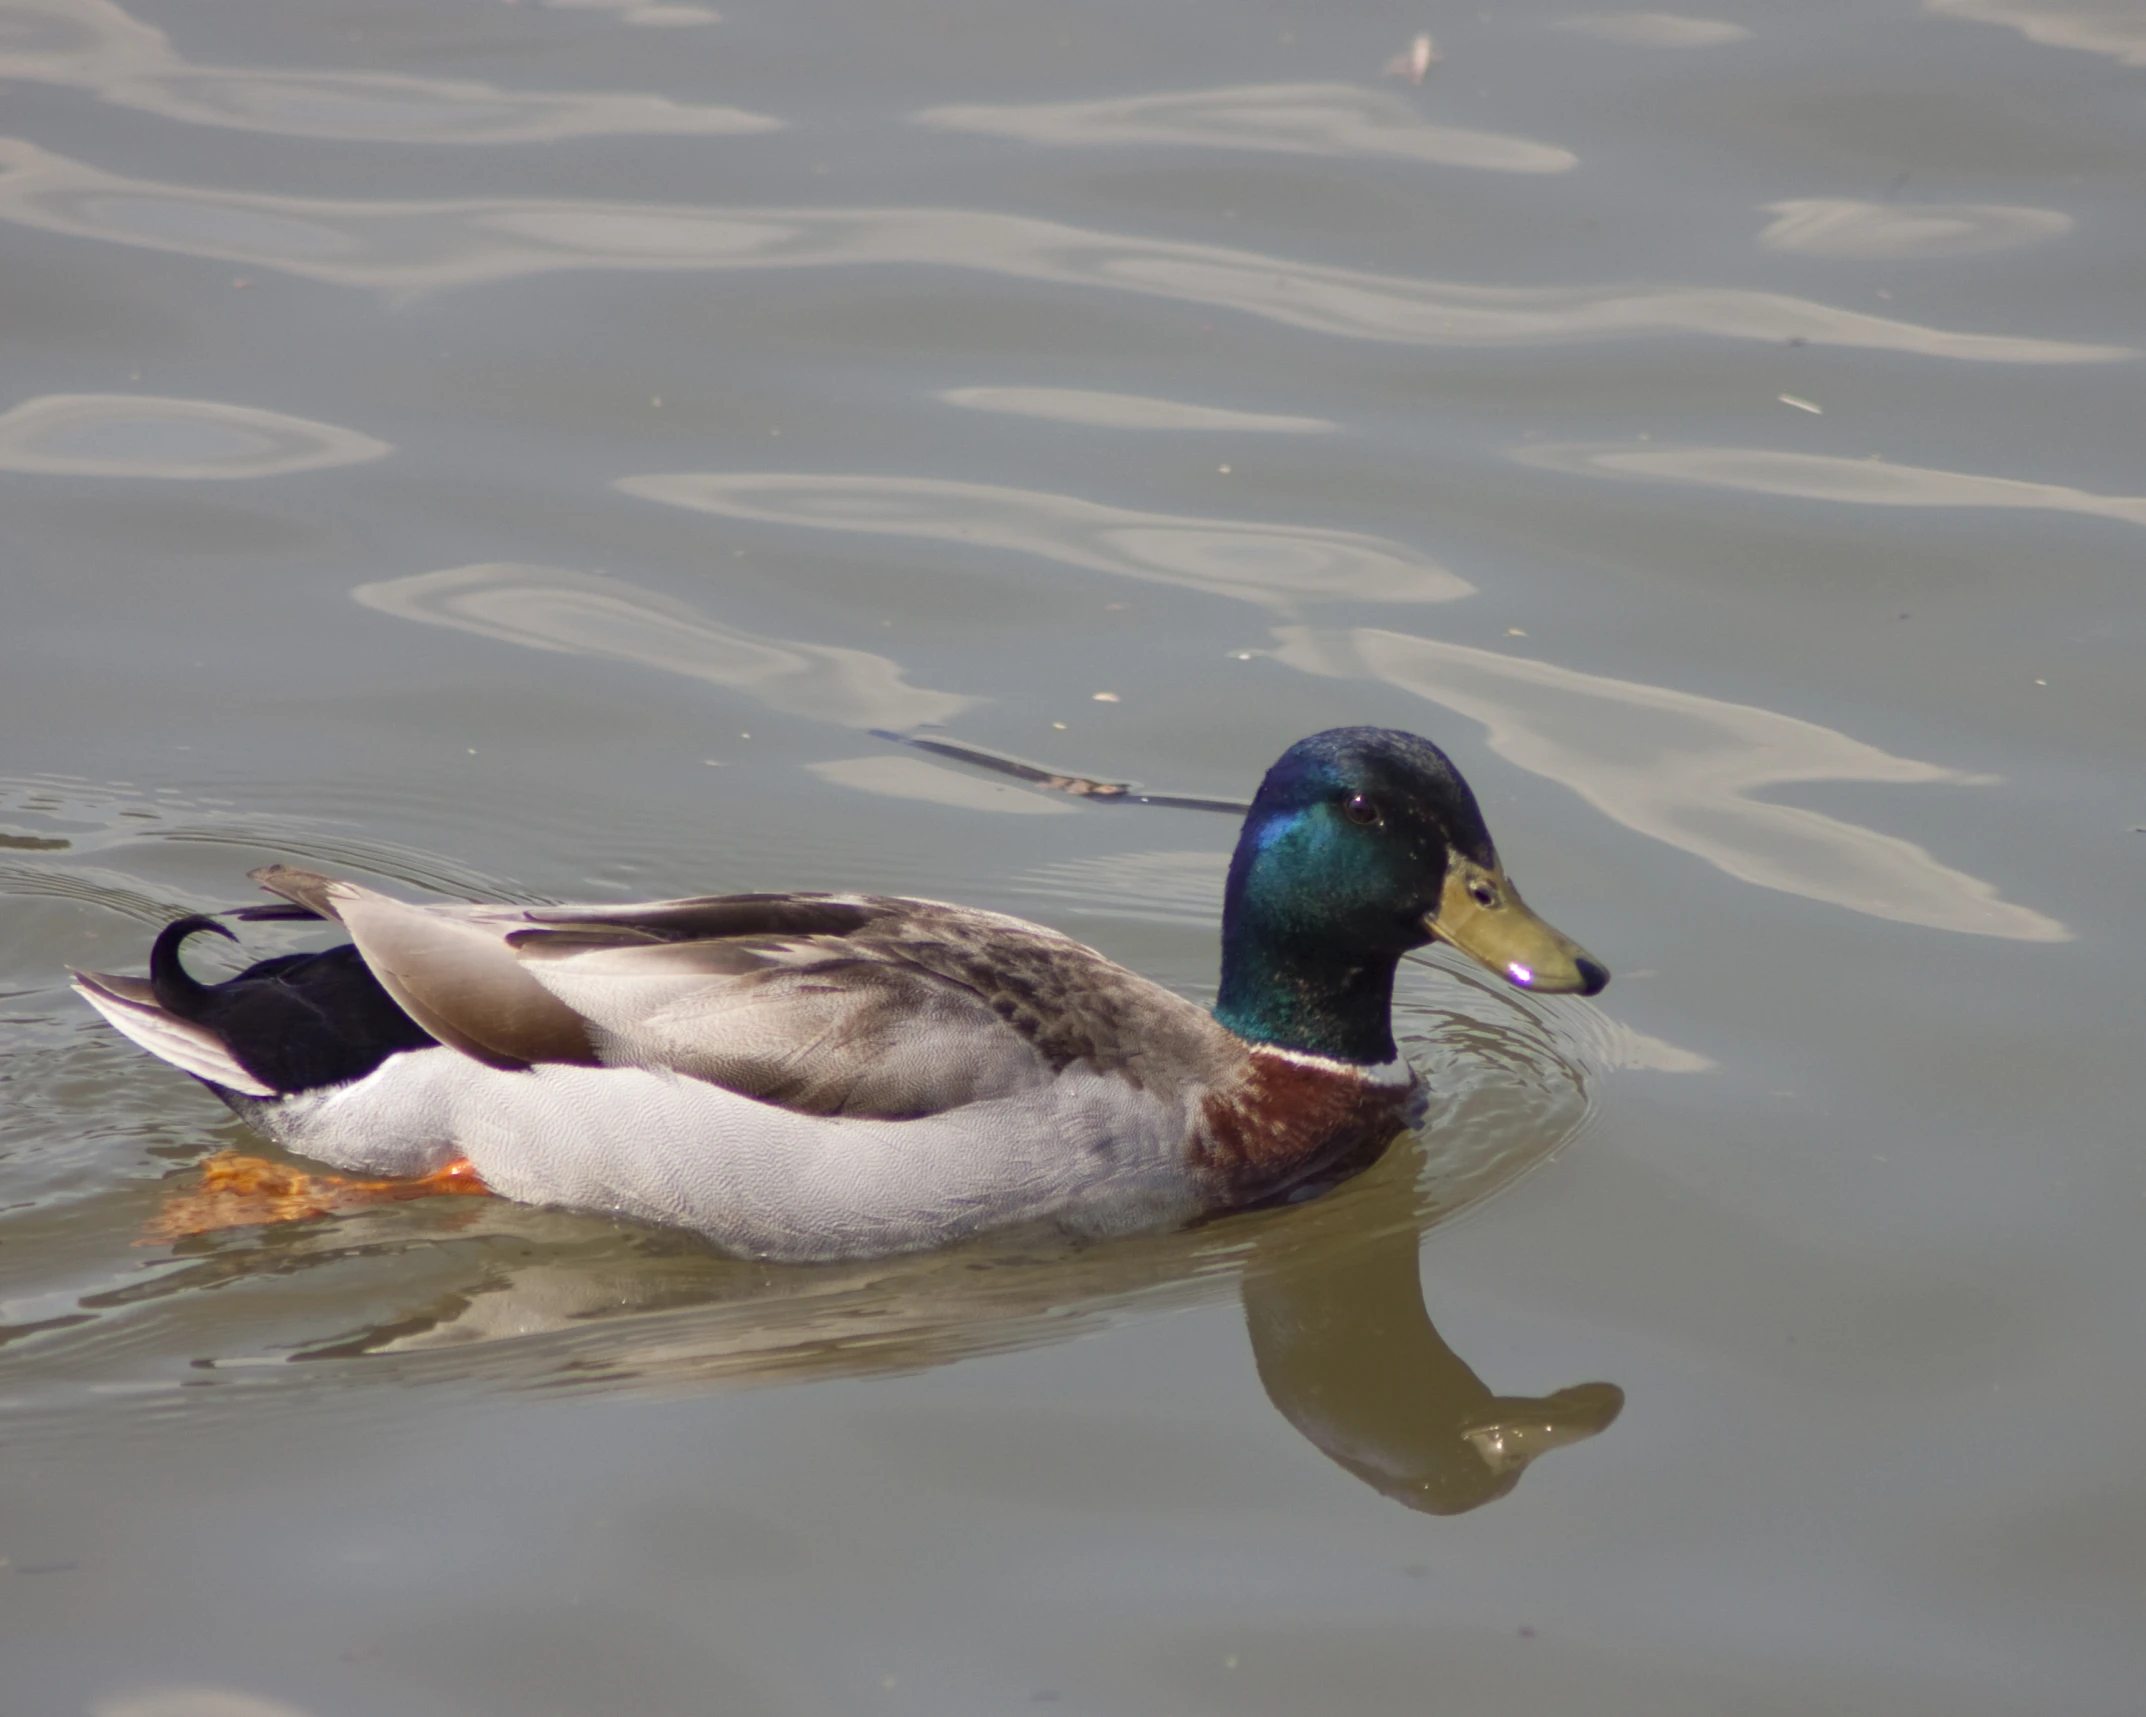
xmin=0 ymin=0 xmax=2146 ymax=1717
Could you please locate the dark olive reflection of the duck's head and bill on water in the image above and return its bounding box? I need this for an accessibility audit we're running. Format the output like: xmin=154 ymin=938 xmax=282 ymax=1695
xmin=1245 ymin=1226 xmax=1625 ymax=1515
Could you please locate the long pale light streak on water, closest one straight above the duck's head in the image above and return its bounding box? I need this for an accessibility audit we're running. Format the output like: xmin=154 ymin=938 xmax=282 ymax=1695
xmin=616 ymin=472 xmax=1474 ymax=607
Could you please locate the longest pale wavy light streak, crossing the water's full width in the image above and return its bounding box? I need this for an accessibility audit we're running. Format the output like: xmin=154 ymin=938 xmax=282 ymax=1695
xmin=0 ymin=140 xmax=2137 ymax=363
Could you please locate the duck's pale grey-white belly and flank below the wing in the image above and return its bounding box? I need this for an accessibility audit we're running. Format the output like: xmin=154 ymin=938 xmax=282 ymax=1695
xmin=258 ymin=1047 xmax=1206 ymax=1262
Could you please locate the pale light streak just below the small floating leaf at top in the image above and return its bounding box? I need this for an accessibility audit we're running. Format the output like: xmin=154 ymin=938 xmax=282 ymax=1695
xmin=912 ymin=84 xmax=1579 ymax=174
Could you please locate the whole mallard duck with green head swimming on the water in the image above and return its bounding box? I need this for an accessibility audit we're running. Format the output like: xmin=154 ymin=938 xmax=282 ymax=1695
xmin=75 ymin=728 xmax=1610 ymax=1260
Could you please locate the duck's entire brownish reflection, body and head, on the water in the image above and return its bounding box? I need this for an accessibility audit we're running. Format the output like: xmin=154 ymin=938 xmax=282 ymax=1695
xmin=147 ymin=1138 xmax=1625 ymax=1515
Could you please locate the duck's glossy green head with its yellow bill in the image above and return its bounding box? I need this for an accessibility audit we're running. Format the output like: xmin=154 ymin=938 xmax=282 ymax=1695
xmin=1215 ymin=728 xmax=1610 ymax=1065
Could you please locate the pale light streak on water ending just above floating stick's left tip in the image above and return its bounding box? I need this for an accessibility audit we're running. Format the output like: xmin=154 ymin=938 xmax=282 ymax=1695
xmin=350 ymin=562 xmax=976 ymax=728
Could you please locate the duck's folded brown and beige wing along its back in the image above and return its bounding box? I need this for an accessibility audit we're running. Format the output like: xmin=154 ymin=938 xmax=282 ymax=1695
xmin=248 ymin=867 xmax=1243 ymax=1118
